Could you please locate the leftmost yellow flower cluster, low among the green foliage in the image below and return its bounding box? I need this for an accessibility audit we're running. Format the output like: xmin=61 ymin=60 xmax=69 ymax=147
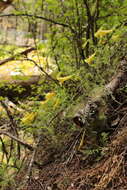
xmin=21 ymin=112 xmax=37 ymax=125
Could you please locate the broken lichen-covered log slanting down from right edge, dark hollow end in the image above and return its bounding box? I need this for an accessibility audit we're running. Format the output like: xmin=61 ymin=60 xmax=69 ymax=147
xmin=73 ymin=60 xmax=127 ymax=127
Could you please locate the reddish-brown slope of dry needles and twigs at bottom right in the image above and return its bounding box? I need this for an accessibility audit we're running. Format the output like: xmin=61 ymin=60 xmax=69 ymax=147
xmin=22 ymin=90 xmax=127 ymax=190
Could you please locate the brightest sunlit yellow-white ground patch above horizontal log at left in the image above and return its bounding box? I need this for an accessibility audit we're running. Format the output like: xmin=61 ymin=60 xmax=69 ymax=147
xmin=0 ymin=51 xmax=56 ymax=80
